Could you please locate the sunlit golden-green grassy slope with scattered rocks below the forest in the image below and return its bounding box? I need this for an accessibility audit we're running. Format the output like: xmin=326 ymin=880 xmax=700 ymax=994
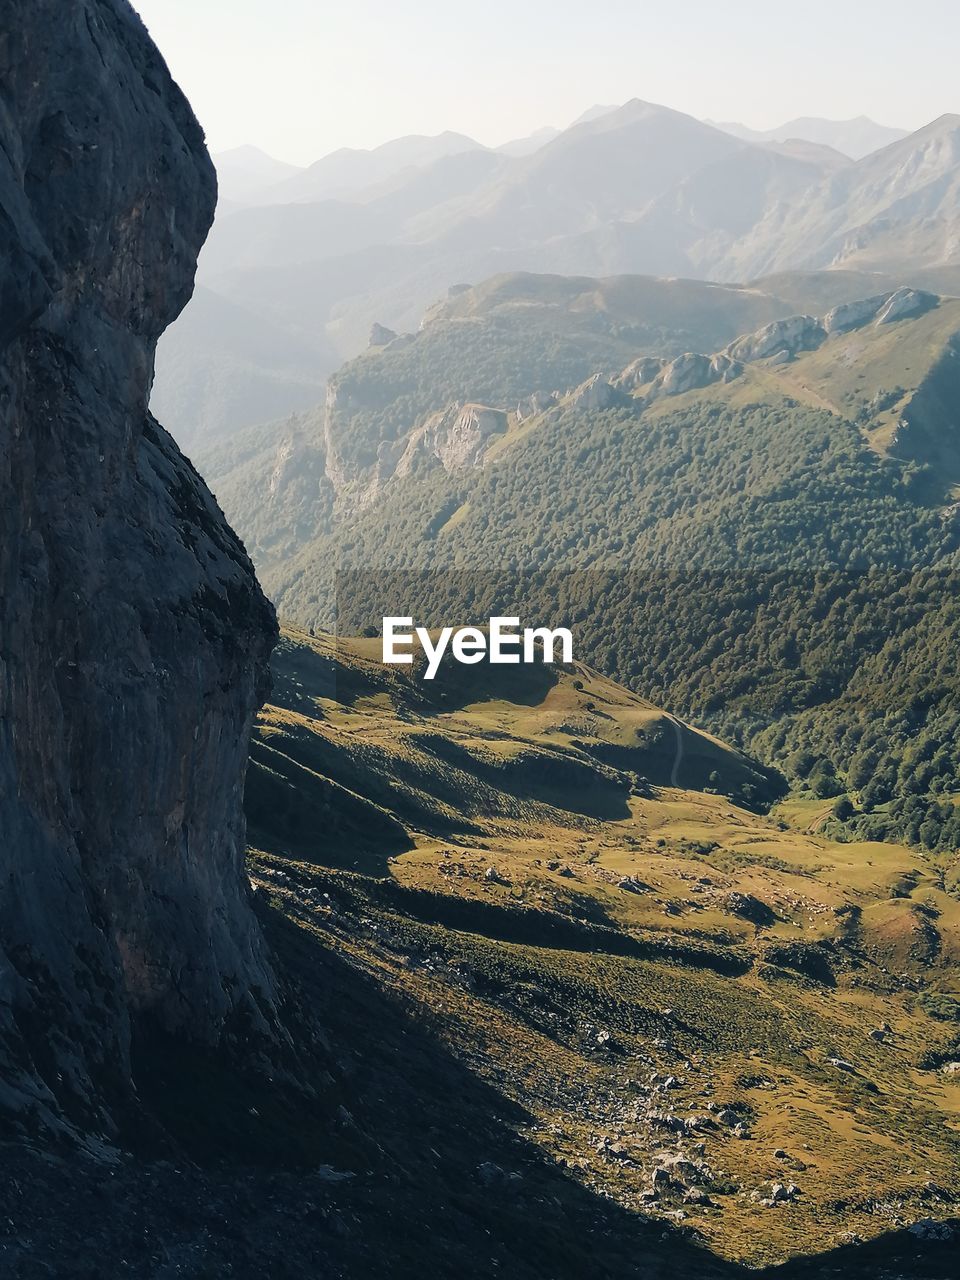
xmin=250 ymin=632 xmax=960 ymax=1274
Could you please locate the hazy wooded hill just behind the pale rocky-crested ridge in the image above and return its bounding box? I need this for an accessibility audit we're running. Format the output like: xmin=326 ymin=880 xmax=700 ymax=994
xmin=197 ymin=273 xmax=849 ymax=565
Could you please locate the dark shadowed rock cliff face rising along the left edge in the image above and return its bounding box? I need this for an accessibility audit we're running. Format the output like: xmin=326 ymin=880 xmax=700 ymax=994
xmin=0 ymin=0 xmax=275 ymax=1133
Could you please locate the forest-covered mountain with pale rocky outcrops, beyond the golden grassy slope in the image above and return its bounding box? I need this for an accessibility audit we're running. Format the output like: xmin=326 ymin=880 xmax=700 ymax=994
xmin=202 ymin=271 xmax=960 ymax=865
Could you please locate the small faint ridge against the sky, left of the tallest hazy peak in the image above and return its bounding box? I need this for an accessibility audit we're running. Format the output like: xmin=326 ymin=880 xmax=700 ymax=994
xmin=259 ymin=132 xmax=484 ymax=205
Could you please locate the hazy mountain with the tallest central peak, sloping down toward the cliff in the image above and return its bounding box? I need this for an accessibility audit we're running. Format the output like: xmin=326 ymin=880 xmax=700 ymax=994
xmin=189 ymin=102 xmax=855 ymax=384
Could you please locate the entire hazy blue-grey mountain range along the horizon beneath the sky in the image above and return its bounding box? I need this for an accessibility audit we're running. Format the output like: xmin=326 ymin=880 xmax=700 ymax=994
xmin=156 ymin=101 xmax=960 ymax=440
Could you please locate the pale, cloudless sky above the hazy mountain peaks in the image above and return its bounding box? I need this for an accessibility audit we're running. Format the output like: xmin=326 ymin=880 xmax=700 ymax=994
xmin=133 ymin=0 xmax=960 ymax=164
